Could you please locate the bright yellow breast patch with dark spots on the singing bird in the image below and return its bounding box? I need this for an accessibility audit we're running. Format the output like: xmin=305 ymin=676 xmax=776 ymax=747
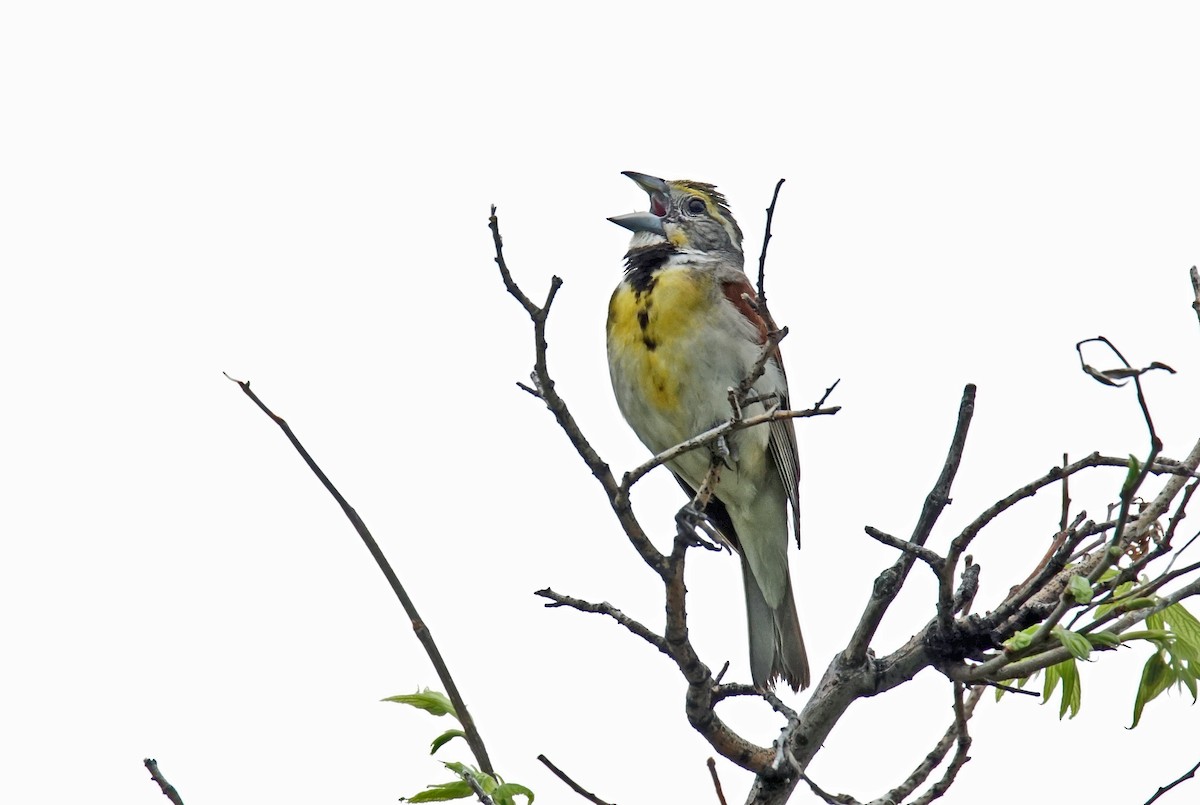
xmin=608 ymin=268 xmax=712 ymax=411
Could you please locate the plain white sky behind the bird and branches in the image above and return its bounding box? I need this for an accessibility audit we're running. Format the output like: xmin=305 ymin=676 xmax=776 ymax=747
xmin=0 ymin=2 xmax=1200 ymax=805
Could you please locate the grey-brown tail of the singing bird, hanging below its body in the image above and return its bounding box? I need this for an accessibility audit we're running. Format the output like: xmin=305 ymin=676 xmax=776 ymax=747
xmin=742 ymin=559 xmax=810 ymax=690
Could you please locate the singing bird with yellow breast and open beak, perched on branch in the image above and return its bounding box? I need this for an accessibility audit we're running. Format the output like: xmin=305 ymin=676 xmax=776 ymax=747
xmin=607 ymin=172 xmax=809 ymax=690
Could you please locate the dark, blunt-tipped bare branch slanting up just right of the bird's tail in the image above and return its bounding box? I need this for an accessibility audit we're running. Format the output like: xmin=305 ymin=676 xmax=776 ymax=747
xmin=841 ymin=384 xmax=976 ymax=666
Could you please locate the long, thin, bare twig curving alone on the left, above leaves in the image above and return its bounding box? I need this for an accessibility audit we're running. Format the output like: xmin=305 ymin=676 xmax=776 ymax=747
xmin=226 ymin=374 xmax=496 ymax=776
